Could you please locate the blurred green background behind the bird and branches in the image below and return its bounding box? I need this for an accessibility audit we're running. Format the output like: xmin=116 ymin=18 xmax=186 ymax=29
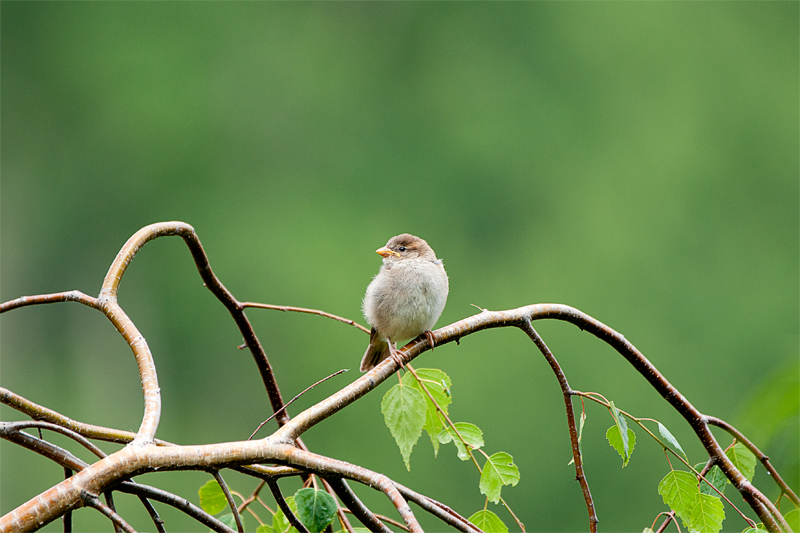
xmin=0 ymin=2 xmax=800 ymax=531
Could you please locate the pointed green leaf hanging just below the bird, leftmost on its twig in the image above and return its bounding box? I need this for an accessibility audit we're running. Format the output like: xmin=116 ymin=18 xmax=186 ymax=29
xmin=381 ymin=383 xmax=426 ymax=471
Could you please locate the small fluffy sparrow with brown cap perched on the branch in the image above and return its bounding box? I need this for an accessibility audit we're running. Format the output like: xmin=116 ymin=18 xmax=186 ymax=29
xmin=361 ymin=233 xmax=449 ymax=372
